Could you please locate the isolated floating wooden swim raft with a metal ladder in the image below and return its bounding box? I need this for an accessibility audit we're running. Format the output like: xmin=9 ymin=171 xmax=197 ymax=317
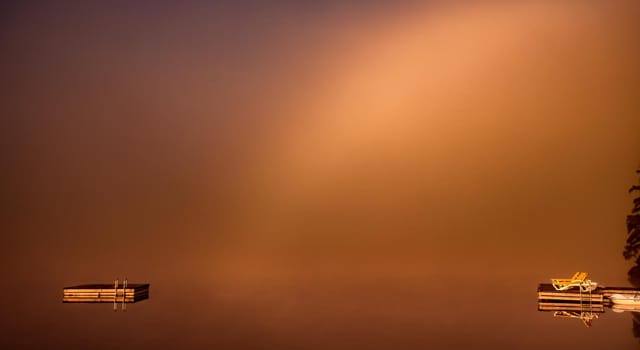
xmin=62 ymin=284 xmax=149 ymax=303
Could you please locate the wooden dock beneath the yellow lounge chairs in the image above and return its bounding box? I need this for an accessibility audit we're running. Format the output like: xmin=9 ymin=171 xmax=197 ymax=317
xmin=538 ymin=283 xmax=640 ymax=305
